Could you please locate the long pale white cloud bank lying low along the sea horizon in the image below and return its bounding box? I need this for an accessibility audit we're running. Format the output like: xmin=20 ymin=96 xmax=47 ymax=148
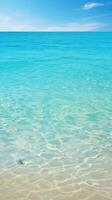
xmin=0 ymin=16 xmax=103 ymax=32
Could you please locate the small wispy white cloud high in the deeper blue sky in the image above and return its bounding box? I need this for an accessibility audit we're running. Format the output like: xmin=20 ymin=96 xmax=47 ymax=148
xmin=83 ymin=2 xmax=104 ymax=10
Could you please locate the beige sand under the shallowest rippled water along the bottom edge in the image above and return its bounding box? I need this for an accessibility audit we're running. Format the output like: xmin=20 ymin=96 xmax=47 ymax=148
xmin=0 ymin=169 xmax=112 ymax=200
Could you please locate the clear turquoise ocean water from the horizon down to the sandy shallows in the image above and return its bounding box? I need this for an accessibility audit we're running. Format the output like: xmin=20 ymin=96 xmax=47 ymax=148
xmin=0 ymin=32 xmax=112 ymax=200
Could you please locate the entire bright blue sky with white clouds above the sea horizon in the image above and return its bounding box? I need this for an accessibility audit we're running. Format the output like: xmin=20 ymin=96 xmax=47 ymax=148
xmin=0 ymin=0 xmax=112 ymax=32
